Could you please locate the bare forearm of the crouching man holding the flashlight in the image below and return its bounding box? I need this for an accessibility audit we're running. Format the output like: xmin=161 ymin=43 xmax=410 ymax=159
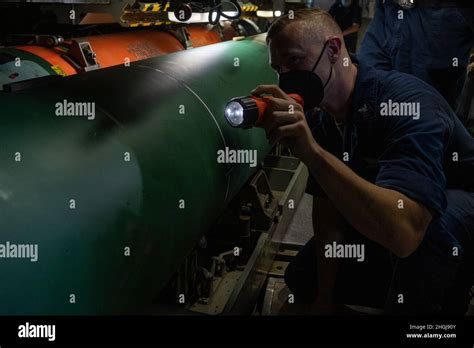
xmin=307 ymin=145 xmax=429 ymax=257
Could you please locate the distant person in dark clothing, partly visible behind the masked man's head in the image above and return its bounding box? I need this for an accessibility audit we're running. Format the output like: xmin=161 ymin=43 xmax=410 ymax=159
xmin=328 ymin=0 xmax=362 ymax=53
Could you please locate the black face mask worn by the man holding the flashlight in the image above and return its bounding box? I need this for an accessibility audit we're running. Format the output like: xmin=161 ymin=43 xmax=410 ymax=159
xmin=278 ymin=41 xmax=332 ymax=111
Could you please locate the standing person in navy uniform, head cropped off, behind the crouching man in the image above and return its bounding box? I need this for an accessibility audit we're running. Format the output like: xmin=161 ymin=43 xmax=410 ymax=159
xmin=358 ymin=0 xmax=474 ymax=110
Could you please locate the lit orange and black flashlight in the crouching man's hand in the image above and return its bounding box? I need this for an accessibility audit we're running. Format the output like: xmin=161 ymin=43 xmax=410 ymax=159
xmin=224 ymin=94 xmax=303 ymax=128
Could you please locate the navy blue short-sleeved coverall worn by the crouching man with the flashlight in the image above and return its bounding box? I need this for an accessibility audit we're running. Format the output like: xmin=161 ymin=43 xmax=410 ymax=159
xmin=285 ymin=60 xmax=474 ymax=314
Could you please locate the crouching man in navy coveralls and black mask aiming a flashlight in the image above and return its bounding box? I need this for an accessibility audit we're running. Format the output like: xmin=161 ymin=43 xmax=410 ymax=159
xmin=253 ymin=9 xmax=474 ymax=314
